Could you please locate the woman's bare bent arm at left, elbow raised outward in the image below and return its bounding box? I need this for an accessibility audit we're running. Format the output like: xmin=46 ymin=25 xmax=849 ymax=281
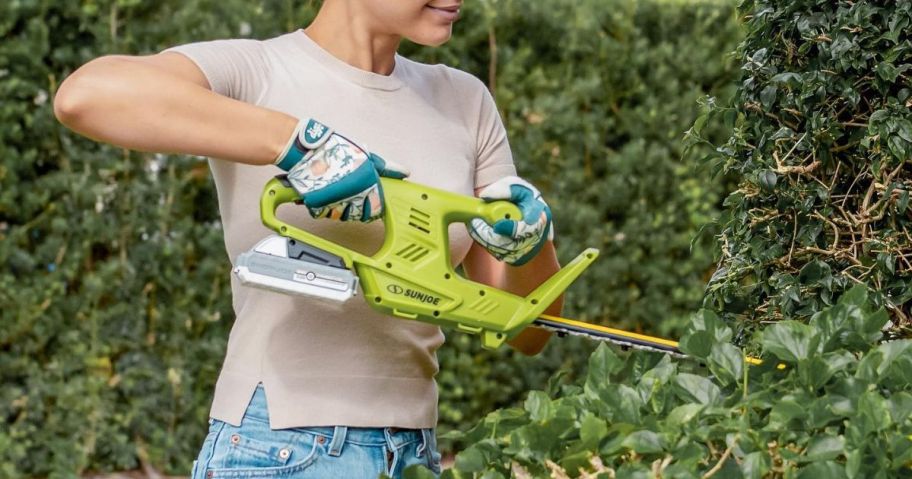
xmin=54 ymin=52 xmax=298 ymax=165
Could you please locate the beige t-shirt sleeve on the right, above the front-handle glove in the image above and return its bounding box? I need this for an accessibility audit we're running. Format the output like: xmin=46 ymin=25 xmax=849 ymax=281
xmin=475 ymin=81 xmax=516 ymax=188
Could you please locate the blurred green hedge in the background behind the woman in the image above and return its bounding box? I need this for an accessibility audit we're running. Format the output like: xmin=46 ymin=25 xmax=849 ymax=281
xmin=0 ymin=0 xmax=740 ymax=478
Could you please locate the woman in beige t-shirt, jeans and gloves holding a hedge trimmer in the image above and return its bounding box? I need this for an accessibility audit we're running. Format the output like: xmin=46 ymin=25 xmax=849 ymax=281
xmin=55 ymin=0 xmax=560 ymax=478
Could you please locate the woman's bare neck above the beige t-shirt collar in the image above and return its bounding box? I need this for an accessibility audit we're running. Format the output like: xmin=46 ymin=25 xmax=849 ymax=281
xmin=304 ymin=1 xmax=402 ymax=75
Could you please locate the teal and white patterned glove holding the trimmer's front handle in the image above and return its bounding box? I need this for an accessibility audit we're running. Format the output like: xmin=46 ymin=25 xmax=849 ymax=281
xmin=469 ymin=176 xmax=554 ymax=266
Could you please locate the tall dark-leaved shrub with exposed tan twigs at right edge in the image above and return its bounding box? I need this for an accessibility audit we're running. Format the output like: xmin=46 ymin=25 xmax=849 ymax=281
xmin=696 ymin=0 xmax=912 ymax=342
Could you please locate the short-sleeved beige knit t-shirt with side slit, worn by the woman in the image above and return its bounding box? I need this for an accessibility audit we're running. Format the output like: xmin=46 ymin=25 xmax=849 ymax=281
xmin=171 ymin=30 xmax=516 ymax=429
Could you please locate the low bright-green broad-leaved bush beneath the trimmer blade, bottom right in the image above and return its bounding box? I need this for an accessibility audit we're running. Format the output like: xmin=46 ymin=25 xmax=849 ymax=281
xmin=432 ymin=286 xmax=912 ymax=479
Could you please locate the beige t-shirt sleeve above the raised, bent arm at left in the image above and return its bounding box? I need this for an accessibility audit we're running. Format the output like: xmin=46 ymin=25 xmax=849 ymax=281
xmin=165 ymin=39 xmax=269 ymax=103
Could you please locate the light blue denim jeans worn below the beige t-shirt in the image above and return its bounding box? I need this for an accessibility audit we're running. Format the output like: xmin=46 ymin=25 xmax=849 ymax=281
xmin=191 ymin=386 xmax=440 ymax=479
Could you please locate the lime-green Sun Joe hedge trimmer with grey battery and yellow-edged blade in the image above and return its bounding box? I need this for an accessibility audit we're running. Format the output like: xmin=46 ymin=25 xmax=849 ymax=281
xmin=234 ymin=175 xmax=720 ymax=356
